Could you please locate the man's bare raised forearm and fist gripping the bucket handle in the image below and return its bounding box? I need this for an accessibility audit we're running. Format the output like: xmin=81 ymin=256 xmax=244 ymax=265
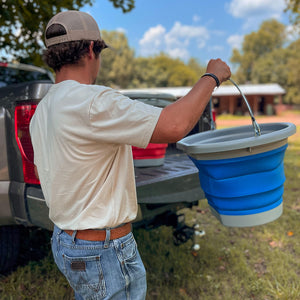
xmin=150 ymin=59 xmax=231 ymax=143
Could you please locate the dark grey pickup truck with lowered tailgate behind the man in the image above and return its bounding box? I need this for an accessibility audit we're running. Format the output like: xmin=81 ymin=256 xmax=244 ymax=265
xmin=0 ymin=63 xmax=212 ymax=273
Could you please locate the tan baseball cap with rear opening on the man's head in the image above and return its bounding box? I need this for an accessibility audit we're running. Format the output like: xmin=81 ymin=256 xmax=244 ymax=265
xmin=45 ymin=10 xmax=102 ymax=47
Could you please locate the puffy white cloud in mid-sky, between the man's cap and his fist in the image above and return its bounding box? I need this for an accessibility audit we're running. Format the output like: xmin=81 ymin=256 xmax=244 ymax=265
xmin=139 ymin=22 xmax=209 ymax=60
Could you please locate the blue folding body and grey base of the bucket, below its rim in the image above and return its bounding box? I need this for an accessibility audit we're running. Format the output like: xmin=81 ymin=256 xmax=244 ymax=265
xmin=190 ymin=144 xmax=287 ymax=227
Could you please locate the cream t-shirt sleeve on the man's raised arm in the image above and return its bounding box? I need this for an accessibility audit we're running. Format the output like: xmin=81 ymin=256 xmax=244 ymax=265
xmin=89 ymin=89 xmax=162 ymax=148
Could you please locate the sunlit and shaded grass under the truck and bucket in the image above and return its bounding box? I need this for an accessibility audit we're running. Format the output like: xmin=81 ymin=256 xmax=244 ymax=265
xmin=0 ymin=119 xmax=300 ymax=300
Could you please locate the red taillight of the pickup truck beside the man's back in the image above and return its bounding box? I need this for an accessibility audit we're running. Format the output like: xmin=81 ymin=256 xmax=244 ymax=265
xmin=15 ymin=104 xmax=40 ymax=184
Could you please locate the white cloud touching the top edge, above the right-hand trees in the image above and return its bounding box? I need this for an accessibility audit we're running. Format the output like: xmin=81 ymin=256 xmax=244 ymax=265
xmin=227 ymin=0 xmax=286 ymax=29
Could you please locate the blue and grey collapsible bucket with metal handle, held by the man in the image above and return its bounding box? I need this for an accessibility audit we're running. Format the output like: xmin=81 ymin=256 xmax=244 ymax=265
xmin=177 ymin=82 xmax=296 ymax=227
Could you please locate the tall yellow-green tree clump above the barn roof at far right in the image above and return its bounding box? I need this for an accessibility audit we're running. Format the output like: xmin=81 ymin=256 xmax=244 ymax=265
xmin=231 ymin=20 xmax=300 ymax=104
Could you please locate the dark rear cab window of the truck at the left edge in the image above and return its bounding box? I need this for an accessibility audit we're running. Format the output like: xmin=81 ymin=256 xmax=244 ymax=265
xmin=0 ymin=66 xmax=51 ymax=87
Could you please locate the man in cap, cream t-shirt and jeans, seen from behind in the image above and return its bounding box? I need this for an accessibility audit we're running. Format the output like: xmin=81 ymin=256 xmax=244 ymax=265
xmin=30 ymin=11 xmax=230 ymax=300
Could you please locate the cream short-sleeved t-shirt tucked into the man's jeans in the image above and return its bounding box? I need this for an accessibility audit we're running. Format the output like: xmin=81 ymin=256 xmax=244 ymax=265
xmin=30 ymin=80 xmax=162 ymax=230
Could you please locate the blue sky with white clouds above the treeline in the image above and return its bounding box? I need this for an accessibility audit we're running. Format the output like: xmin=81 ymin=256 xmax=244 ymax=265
xmin=81 ymin=0 xmax=296 ymax=64
